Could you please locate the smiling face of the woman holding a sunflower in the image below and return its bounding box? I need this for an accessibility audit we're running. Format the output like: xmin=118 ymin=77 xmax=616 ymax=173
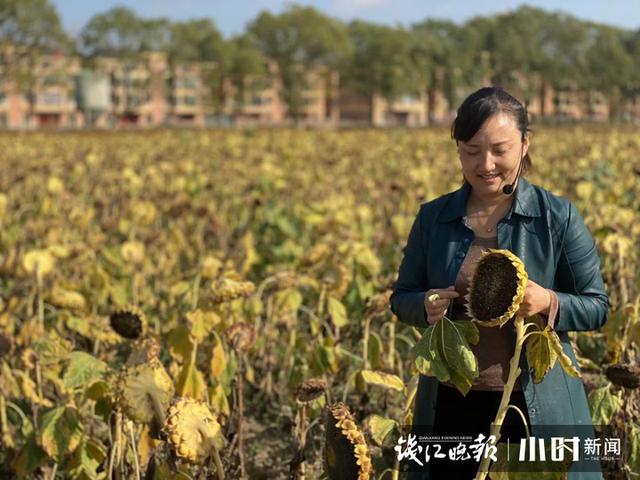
xmin=458 ymin=113 xmax=529 ymax=201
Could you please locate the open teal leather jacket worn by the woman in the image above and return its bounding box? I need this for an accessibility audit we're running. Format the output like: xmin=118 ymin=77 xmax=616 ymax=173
xmin=390 ymin=177 xmax=609 ymax=480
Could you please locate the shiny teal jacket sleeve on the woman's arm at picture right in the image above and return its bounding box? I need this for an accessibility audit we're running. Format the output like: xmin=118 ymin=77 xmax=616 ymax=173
xmin=554 ymin=203 xmax=609 ymax=331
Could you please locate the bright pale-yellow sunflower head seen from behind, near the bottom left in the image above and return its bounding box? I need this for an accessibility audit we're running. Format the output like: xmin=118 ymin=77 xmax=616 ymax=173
xmin=164 ymin=398 xmax=222 ymax=464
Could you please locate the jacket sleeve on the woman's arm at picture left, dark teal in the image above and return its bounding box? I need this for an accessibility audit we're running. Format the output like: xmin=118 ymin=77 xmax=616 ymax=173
xmin=390 ymin=202 xmax=429 ymax=328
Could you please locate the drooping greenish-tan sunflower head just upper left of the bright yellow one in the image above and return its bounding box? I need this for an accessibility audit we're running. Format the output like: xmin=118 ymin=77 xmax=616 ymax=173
xmin=117 ymin=358 xmax=175 ymax=424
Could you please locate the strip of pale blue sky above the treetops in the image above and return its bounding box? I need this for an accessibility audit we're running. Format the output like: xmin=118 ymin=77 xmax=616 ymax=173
xmin=50 ymin=0 xmax=640 ymax=37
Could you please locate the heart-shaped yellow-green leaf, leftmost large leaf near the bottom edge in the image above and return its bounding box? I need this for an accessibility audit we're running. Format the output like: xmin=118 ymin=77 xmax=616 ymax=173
xmin=40 ymin=406 xmax=83 ymax=460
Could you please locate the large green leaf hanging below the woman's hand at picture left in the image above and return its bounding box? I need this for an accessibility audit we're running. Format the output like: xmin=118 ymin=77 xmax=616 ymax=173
xmin=411 ymin=317 xmax=480 ymax=395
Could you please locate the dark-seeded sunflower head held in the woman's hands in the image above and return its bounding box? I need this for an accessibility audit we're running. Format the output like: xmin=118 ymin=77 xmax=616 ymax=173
xmin=465 ymin=248 xmax=528 ymax=327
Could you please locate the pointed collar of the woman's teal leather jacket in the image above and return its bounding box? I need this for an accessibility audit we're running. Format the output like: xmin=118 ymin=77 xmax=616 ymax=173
xmin=438 ymin=177 xmax=541 ymax=223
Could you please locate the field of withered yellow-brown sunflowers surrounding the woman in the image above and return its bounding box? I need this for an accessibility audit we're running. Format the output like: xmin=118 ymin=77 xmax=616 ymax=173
xmin=0 ymin=125 xmax=640 ymax=480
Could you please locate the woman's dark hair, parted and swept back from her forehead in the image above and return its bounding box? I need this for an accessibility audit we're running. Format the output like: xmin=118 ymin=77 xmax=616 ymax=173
xmin=451 ymin=87 xmax=532 ymax=172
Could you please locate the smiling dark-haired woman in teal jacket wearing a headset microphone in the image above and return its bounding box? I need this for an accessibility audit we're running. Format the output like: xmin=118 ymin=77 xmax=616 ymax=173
xmin=390 ymin=87 xmax=609 ymax=480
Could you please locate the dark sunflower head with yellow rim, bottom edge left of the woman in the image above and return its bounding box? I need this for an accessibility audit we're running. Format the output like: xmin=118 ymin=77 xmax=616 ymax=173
xmin=324 ymin=402 xmax=372 ymax=480
